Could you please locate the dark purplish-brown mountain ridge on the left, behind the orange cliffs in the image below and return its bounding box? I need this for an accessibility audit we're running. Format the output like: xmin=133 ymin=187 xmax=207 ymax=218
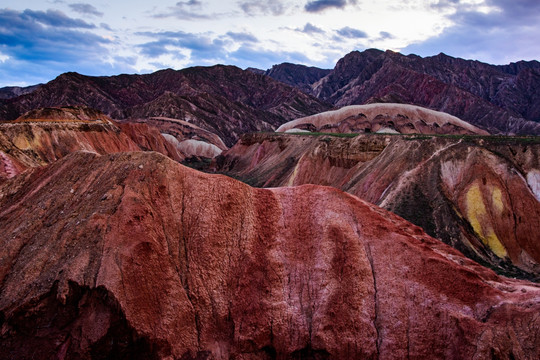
xmin=0 ymin=65 xmax=330 ymax=146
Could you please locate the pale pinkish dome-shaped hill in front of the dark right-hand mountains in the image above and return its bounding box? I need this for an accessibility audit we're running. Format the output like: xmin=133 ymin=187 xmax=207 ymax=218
xmin=276 ymin=103 xmax=489 ymax=135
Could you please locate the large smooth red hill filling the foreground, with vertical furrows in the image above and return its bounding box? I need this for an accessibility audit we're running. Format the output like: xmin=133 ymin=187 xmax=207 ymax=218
xmin=0 ymin=152 xmax=540 ymax=359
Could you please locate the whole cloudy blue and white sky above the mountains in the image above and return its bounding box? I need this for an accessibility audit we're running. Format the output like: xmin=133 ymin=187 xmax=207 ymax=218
xmin=0 ymin=0 xmax=540 ymax=87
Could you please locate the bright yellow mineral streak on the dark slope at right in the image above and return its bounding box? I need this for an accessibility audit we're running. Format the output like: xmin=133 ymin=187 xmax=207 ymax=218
xmin=466 ymin=184 xmax=507 ymax=258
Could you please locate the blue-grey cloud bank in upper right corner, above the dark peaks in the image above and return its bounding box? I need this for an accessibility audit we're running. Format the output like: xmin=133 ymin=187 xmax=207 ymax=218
xmin=403 ymin=0 xmax=540 ymax=63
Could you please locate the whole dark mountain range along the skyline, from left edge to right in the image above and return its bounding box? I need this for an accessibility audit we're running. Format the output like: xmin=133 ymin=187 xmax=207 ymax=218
xmin=0 ymin=49 xmax=540 ymax=141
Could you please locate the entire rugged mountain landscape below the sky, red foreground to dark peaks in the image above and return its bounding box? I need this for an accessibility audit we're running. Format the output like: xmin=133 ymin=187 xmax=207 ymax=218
xmin=0 ymin=49 xmax=540 ymax=360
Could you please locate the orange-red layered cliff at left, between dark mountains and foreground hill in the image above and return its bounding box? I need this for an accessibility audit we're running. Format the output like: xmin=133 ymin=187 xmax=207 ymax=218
xmin=0 ymin=107 xmax=184 ymax=181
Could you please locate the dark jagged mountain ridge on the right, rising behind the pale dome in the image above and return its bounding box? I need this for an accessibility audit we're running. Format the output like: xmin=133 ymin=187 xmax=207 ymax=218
xmin=268 ymin=49 xmax=540 ymax=134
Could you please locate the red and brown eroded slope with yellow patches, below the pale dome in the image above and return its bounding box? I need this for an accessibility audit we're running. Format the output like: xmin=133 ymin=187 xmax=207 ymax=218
xmin=214 ymin=134 xmax=540 ymax=280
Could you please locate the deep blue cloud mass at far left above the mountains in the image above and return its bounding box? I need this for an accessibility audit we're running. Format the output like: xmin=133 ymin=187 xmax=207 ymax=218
xmin=0 ymin=9 xmax=133 ymax=85
